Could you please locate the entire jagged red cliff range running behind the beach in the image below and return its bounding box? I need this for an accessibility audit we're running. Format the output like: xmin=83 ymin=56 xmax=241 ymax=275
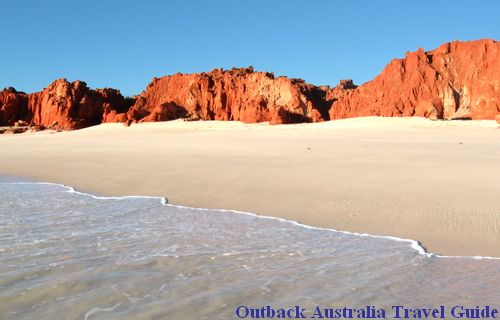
xmin=0 ymin=40 xmax=500 ymax=130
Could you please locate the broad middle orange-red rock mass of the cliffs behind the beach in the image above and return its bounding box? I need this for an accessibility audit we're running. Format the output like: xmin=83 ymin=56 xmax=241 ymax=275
xmin=123 ymin=67 xmax=329 ymax=123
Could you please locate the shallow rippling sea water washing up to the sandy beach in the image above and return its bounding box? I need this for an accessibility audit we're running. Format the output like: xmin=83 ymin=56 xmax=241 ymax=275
xmin=0 ymin=178 xmax=500 ymax=320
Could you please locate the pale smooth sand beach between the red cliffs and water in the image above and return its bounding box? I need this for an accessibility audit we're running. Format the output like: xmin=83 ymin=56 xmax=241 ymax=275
xmin=0 ymin=118 xmax=500 ymax=257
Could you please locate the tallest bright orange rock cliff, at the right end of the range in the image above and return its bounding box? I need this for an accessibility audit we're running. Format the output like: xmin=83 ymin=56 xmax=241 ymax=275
xmin=329 ymin=40 xmax=500 ymax=119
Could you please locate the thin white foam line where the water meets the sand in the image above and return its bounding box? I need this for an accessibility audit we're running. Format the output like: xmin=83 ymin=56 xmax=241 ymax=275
xmin=0 ymin=182 xmax=500 ymax=260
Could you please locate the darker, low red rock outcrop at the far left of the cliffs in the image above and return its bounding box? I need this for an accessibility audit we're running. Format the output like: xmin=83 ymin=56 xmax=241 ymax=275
xmin=0 ymin=79 xmax=134 ymax=130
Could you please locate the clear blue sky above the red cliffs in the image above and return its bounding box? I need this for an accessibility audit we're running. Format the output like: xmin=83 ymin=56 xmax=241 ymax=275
xmin=0 ymin=0 xmax=500 ymax=95
